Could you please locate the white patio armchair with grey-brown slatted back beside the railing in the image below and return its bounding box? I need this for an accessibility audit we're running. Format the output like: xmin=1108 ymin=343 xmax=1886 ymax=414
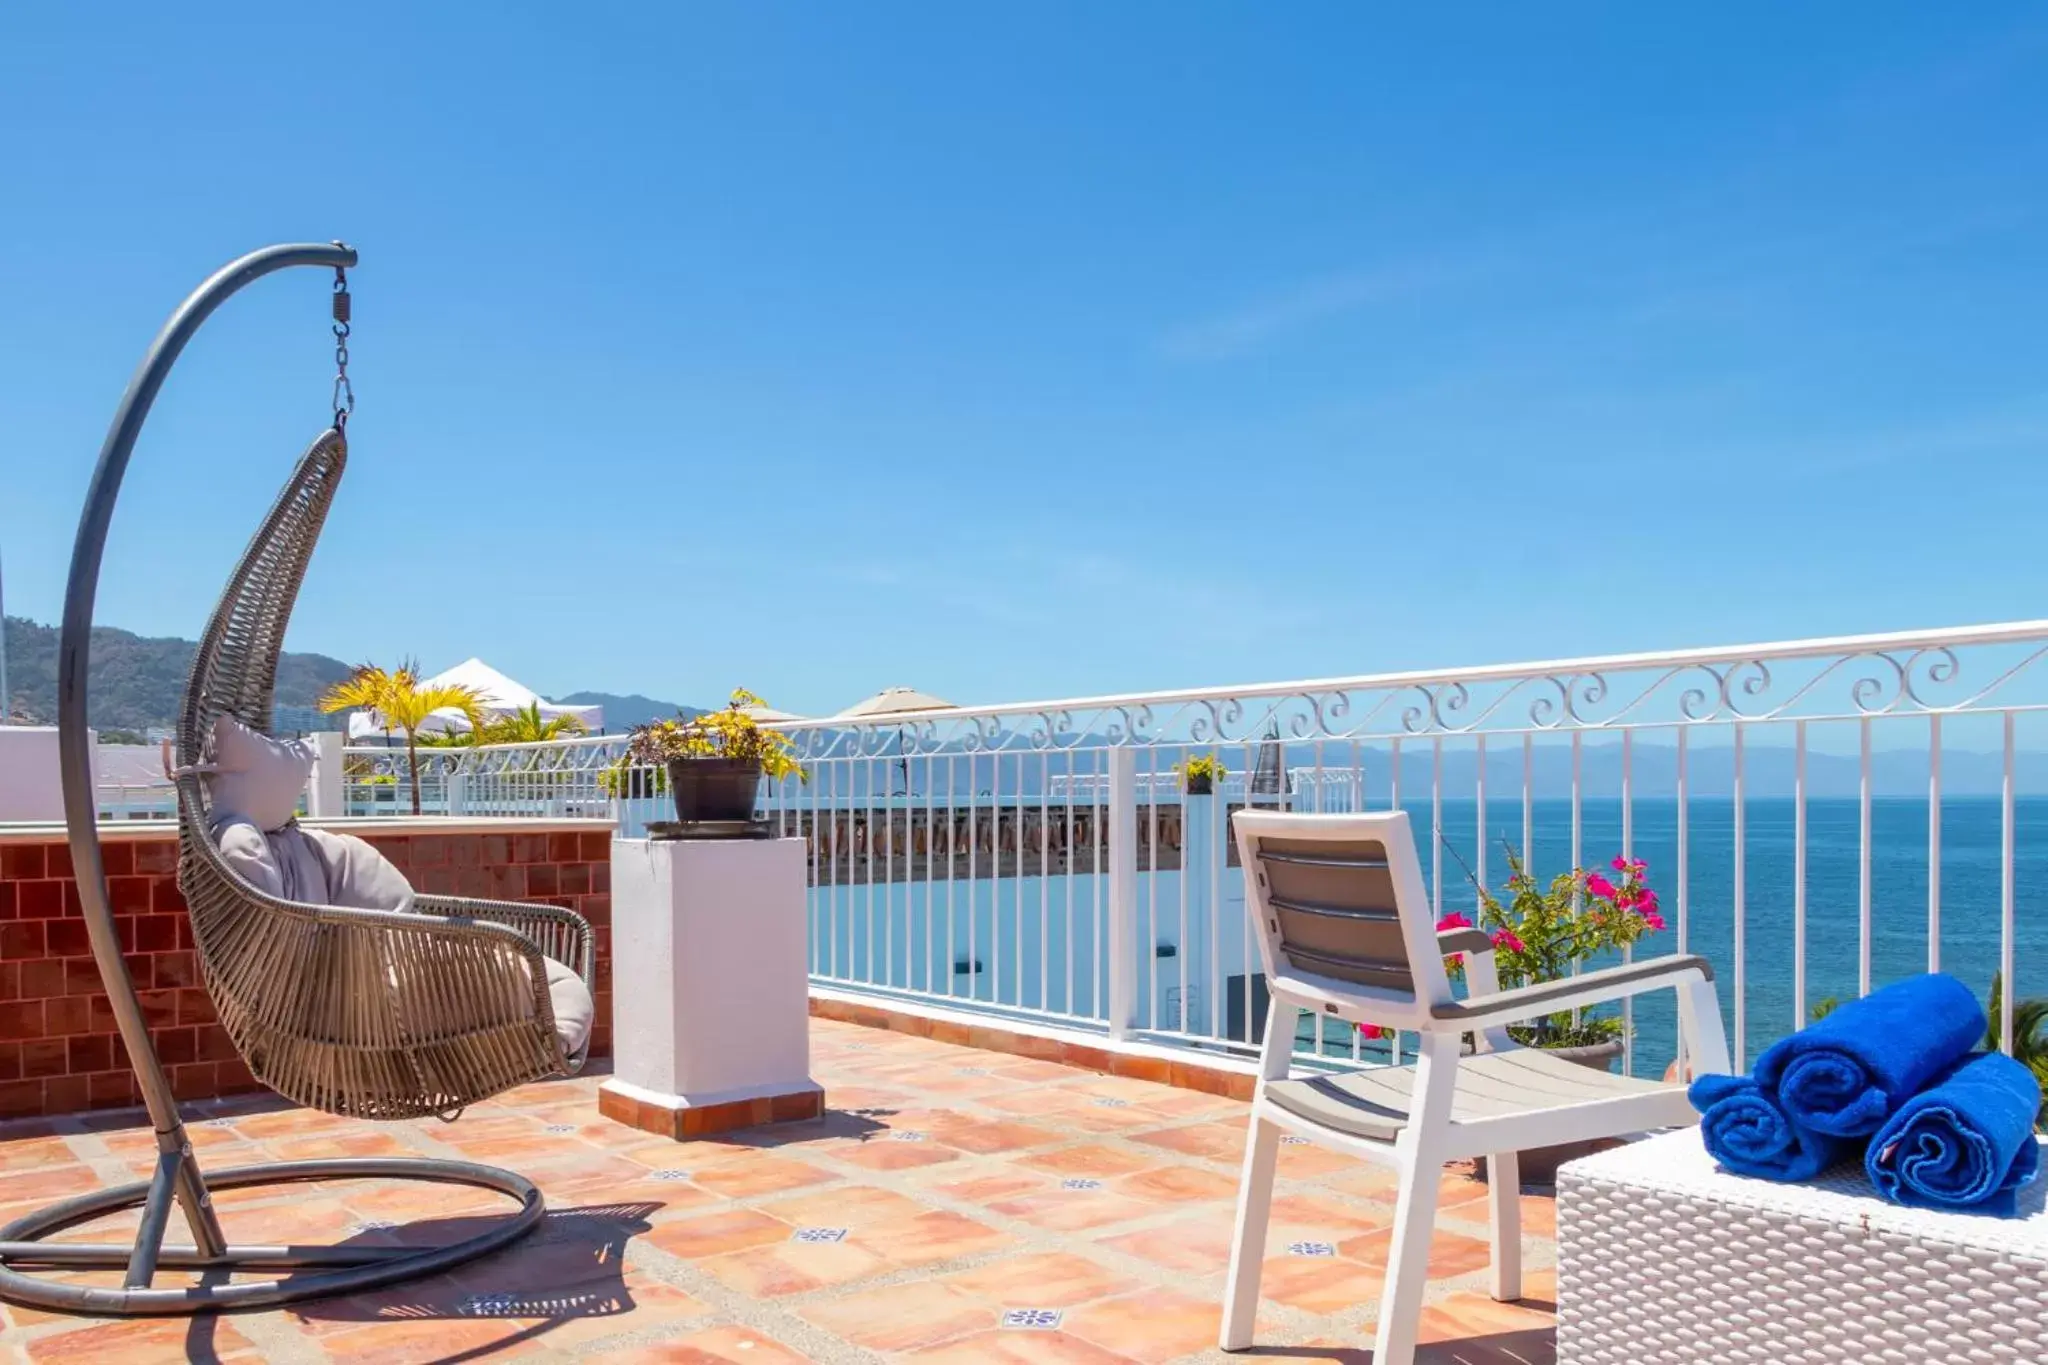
xmin=1223 ymin=810 xmax=1729 ymax=1365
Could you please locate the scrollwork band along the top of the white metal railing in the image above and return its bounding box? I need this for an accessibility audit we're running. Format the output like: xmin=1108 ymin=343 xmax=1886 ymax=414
xmin=344 ymin=622 xmax=2048 ymax=806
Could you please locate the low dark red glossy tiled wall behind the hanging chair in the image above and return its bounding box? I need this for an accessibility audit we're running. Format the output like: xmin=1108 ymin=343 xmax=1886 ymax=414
xmin=0 ymin=831 xmax=612 ymax=1117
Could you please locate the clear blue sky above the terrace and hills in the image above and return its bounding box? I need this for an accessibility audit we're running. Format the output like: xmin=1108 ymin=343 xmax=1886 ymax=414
xmin=0 ymin=4 xmax=2048 ymax=712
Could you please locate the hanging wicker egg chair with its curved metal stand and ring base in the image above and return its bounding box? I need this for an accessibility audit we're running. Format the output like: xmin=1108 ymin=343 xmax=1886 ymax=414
xmin=0 ymin=244 xmax=594 ymax=1314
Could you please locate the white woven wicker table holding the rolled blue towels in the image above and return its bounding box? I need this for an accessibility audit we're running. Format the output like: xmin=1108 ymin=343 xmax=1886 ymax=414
xmin=1556 ymin=1128 xmax=2048 ymax=1365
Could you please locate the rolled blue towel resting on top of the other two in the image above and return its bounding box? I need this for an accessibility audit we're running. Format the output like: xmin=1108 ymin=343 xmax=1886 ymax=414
xmin=1755 ymin=972 xmax=1991 ymax=1138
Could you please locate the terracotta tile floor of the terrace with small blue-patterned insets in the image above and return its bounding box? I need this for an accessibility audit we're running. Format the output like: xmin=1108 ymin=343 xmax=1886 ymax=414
xmin=0 ymin=1019 xmax=1554 ymax=1365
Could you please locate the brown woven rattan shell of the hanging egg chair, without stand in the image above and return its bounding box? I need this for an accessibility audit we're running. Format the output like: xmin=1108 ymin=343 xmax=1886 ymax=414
xmin=176 ymin=432 xmax=594 ymax=1119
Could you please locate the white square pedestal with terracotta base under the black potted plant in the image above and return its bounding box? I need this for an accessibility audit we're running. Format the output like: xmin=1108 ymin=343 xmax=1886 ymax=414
xmin=598 ymin=839 xmax=825 ymax=1138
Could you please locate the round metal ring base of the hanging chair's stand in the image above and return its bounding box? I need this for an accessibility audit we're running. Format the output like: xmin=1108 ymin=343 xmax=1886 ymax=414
xmin=0 ymin=1158 xmax=547 ymax=1316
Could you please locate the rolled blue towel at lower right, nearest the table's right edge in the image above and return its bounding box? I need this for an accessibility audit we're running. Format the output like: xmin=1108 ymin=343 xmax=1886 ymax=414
xmin=1864 ymin=1052 xmax=2042 ymax=1218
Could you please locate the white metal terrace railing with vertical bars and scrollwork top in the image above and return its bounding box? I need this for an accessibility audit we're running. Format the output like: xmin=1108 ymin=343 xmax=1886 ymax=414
xmin=346 ymin=622 xmax=2048 ymax=1070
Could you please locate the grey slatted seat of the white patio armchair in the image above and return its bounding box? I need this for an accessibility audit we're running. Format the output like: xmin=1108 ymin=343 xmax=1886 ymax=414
xmin=1266 ymin=1048 xmax=1675 ymax=1142
